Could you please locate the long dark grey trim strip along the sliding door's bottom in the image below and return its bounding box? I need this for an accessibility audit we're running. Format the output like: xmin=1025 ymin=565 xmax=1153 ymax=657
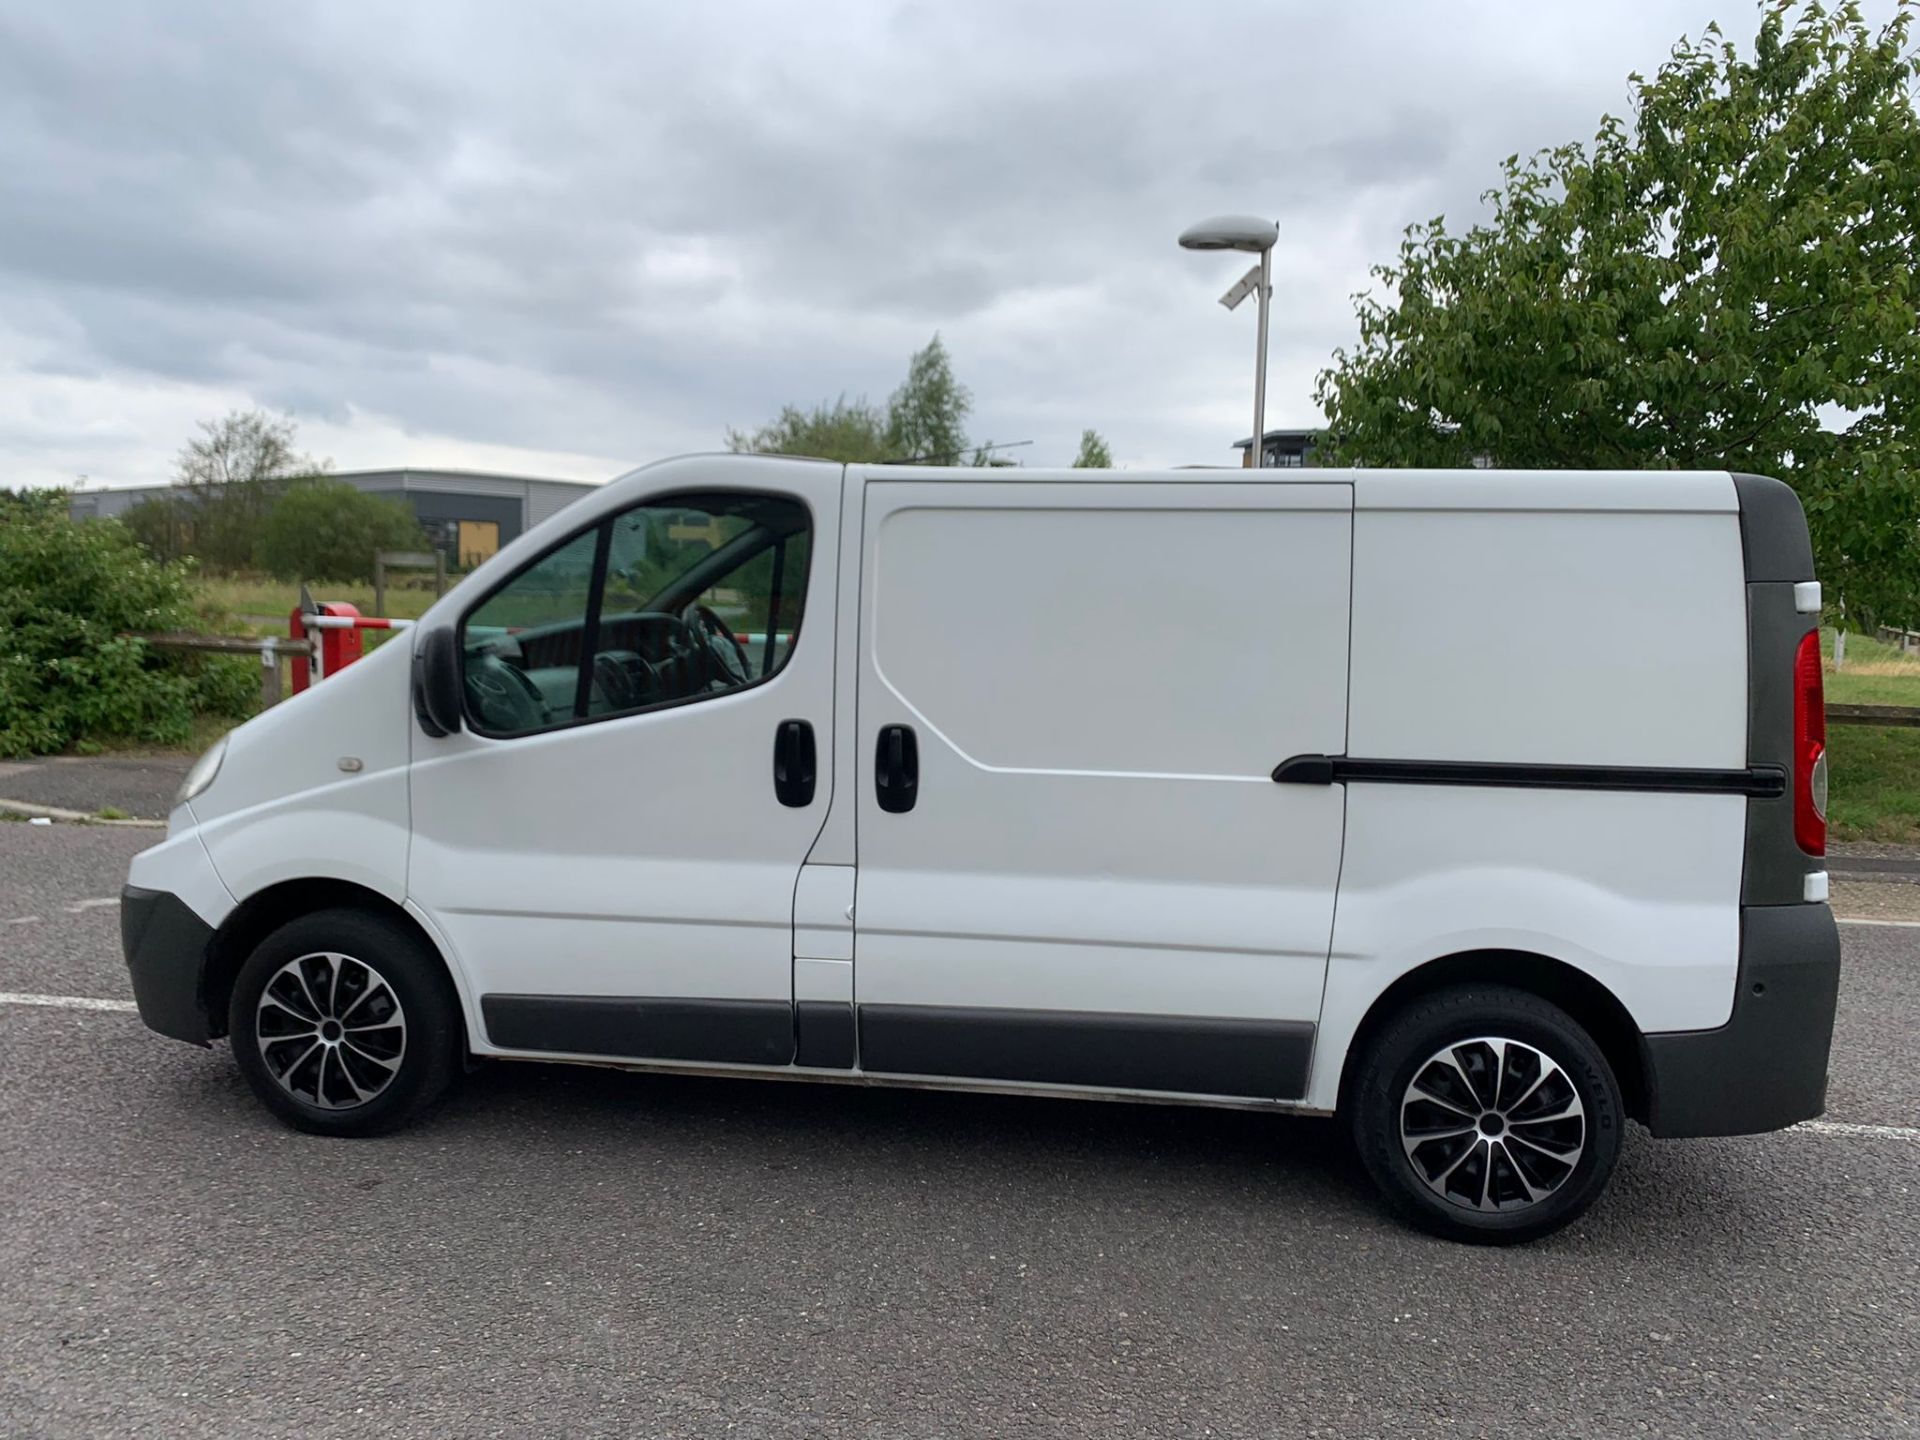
xmin=858 ymin=1004 xmax=1313 ymax=1100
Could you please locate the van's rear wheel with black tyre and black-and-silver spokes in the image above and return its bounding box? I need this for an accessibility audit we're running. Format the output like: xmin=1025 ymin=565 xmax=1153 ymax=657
xmin=1346 ymin=985 xmax=1624 ymax=1244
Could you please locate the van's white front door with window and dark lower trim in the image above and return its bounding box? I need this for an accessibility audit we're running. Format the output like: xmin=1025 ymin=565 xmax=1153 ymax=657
xmin=409 ymin=463 xmax=843 ymax=1066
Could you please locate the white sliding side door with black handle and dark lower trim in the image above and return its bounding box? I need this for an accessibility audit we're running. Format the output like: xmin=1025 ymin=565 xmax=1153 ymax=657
xmin=854 ymin=478 xmax=1352 ymax=1098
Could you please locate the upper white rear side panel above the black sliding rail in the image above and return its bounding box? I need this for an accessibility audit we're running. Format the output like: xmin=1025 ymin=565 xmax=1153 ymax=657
xmin=1348 ymin=514 xmax=1747 ymax=768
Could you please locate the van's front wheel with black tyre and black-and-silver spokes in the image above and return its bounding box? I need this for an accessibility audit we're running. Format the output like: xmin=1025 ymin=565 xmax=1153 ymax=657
xmin=228 ymin=910 xmax=461 ymax=1135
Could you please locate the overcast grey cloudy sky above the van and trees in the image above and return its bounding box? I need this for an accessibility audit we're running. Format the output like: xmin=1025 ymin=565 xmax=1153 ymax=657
xmin=0 ymin=0 xmax=1858 ymax=484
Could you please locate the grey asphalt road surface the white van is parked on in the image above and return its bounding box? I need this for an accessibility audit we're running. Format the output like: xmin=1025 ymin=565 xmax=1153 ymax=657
xmin=0 ymin=824 xmax=1920 ymax=1438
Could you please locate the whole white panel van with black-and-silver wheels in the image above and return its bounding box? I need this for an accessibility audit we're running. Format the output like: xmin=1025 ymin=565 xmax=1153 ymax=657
xmin=123 ymin=455 xmax=1839 ymax=1242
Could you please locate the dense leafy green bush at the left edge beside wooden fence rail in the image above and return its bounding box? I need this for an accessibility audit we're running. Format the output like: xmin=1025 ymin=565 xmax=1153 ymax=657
xmin=0 ymin=490 xmax=259 ymax=756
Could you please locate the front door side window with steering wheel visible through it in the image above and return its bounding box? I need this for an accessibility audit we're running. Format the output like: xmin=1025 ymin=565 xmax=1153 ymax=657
xmin=461 ymin=493 xmax=810 ymax=735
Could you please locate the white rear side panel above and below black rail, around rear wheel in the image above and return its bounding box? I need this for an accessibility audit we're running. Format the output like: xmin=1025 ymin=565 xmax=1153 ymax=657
xmin=1308 ymin=495 xmax=1747 ymax=1108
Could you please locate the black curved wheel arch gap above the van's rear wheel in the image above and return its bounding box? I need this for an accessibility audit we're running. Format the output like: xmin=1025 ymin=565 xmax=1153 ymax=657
xmin=1340 ymin=950 xmax=1649 ymax=1123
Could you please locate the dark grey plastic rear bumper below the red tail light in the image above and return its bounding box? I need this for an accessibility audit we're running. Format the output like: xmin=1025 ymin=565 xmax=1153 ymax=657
xmin=1645 ymin=904 xmax=1839 ymax=1137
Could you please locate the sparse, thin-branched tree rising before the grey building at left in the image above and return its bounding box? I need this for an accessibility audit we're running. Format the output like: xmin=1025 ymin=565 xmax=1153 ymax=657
xmin=175 ymin=411 xmax=334 ymax=578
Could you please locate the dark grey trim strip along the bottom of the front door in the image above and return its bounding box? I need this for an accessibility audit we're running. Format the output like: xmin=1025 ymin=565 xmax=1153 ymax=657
xmin=480 ymin=995 xmax=793 ymax=1066
